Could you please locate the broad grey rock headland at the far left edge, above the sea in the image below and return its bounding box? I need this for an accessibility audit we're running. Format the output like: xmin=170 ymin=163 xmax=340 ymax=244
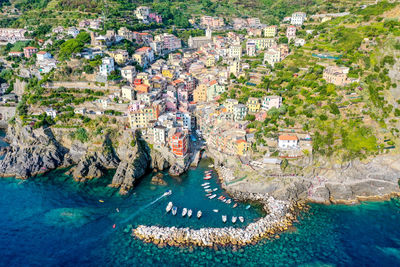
xmin=0 ymin=124 xmax=68 ymax=179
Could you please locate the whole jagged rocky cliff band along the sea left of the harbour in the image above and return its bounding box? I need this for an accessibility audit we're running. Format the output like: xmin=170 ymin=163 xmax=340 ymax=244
xmin=0 ymin=125 xmax=170 ymax=193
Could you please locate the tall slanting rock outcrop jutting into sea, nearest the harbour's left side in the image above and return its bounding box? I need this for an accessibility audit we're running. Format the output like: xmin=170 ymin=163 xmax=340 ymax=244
xmin=110 ymin=132 xmax=169 ymax=194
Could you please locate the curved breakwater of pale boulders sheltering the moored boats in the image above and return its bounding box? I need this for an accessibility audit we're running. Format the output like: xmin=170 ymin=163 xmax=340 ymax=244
xmin=132 ymin=194 xmax=302 ymax=247
